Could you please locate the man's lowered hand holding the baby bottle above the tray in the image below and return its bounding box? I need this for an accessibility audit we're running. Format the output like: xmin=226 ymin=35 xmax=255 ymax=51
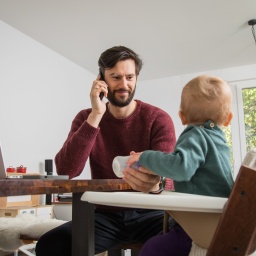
xmin=123 ymin=166 xmax=160 ymax=193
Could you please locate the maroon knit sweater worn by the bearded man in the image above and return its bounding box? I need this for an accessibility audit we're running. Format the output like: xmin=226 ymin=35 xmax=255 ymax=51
xmin=55 ymin=100 xmax=176 ymax=179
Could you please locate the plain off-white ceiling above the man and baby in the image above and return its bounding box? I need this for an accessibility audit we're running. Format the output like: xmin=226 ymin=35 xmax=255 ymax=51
xmin=0 ymin=0 xmax=256 ymax=80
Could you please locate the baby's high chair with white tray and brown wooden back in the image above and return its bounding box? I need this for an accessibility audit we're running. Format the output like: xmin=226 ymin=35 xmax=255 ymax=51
xmin=81 ymin=149 xmax=256 ymax=256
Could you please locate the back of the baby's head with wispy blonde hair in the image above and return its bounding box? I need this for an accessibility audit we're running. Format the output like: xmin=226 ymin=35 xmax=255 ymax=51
xmin=180 ymin=75 xmax=232 ymax=126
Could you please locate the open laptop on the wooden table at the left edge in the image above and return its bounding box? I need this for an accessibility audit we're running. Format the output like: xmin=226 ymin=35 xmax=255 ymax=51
xmin=0 ymin=143 xmax=69 ymax=180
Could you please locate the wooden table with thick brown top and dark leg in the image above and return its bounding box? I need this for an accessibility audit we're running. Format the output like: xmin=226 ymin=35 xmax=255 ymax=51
xmin=0 ymin=179 xmax=131 ymax=256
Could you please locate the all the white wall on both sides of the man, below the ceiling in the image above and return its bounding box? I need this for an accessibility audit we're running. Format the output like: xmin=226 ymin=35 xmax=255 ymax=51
xmin=0 ymin=21 xmax=256 ymax=178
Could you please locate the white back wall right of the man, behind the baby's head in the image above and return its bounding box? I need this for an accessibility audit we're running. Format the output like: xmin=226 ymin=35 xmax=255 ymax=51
xmin=136 ymin=64 xmax=256 ymax=137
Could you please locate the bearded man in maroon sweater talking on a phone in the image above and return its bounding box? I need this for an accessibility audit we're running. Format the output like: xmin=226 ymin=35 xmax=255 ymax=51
xmin=36 ymin=46 xmax=176 ymax=256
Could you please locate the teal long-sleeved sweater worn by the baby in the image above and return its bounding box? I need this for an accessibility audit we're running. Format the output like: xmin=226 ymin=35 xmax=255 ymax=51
xmin=139 ymin=121 xmax=234 ymax=197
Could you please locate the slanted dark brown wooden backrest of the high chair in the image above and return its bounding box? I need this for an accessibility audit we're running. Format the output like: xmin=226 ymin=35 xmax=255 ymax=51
xmin=207 ymin=149 xmax=256 ymax=256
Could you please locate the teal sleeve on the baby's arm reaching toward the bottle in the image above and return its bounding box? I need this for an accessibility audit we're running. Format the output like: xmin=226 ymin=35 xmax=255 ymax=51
xmin=139 ymin=129 xmax=207 ymax=181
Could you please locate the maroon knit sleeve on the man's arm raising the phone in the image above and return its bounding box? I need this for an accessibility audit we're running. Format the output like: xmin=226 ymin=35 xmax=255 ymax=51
xmin=55 ymin=111 xmax=100 ymax=179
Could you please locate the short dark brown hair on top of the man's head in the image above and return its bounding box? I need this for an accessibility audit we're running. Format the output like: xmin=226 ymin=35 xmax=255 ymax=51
xmin=98 ymin=46 xmax=143 ymax=76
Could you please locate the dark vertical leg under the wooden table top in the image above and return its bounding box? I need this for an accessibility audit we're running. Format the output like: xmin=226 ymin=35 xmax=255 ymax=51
xmin=72 ymin=193 xmax=94 ymax=256
